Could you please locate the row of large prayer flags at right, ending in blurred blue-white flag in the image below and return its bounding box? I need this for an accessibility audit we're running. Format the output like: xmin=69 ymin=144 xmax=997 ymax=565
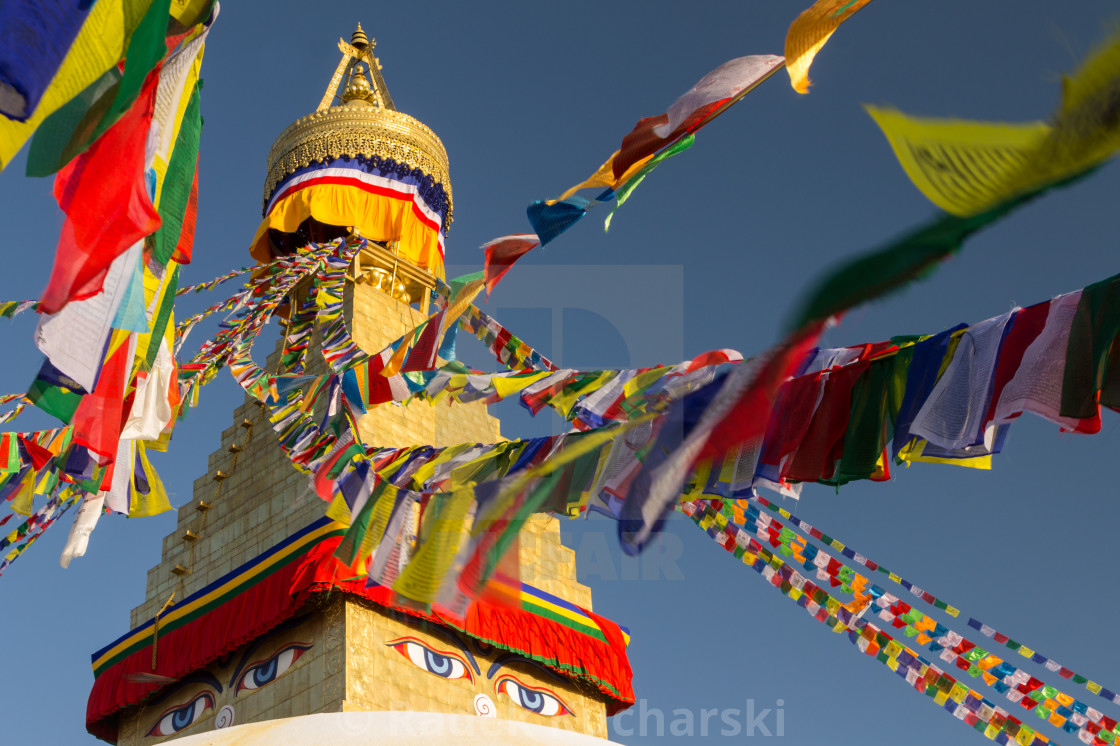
xmin=617 ymin=265 xmax=1120 ymax=551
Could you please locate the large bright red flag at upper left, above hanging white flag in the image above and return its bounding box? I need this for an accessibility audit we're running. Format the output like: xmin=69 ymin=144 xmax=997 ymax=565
xmin=39 ymin=67 xmax=160 ymax=314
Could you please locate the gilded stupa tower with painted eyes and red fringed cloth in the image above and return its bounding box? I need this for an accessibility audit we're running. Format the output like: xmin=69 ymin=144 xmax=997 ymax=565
xmin=81 ymin=26 xmax=633 ymax=745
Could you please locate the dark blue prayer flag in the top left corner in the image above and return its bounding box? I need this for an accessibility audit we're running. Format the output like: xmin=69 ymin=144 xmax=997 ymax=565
xmin=0 ymin=0 xmax=93 ymax=122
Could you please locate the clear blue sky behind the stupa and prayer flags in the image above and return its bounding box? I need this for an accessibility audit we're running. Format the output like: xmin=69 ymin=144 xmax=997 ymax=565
xmin=0 ymin=0 xmax=1120 ymax=746
